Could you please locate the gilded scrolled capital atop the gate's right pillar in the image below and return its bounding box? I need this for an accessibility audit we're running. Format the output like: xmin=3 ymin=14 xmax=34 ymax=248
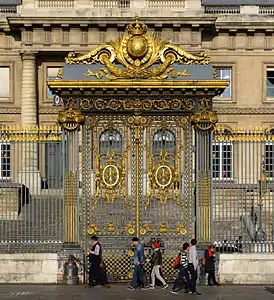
xmin=191 ymin=110 xmax=218 ymax=131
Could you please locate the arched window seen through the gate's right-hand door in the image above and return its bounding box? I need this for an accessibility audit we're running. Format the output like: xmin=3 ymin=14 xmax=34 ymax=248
xmin=152 ymin=130 xmax=176 ymax=154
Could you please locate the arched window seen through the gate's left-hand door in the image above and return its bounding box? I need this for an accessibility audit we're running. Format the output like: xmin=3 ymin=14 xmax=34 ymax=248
xmin=99 ymin=130 xmax=122 ymax=154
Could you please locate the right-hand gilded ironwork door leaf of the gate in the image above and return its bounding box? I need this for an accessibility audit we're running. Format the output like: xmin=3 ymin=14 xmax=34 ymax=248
xmin=140 ymin=116 xmax=193 ymax=248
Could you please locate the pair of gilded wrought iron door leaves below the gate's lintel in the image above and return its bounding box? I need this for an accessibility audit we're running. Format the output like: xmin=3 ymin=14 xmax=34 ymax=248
xmin=82 ymin=115 xmax=194 ymax=279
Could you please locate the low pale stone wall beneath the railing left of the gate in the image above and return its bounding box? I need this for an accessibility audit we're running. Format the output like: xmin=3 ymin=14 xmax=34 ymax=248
xmin=0 ymin=253 xmax=58 ymax=283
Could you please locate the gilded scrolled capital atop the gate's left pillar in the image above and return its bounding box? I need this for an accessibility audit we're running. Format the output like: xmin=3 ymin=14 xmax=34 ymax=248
xmin=58 ymin=108 xmax=85 ymax=131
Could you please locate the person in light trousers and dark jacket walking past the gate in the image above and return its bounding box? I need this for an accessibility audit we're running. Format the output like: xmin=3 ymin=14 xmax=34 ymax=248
xmin=150 ymin=241 xmax=168 ymax=289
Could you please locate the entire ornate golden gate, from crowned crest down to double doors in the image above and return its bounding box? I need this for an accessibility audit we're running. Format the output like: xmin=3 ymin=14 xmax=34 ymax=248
xmin=49 ymin=18 xmax=228 ymax=280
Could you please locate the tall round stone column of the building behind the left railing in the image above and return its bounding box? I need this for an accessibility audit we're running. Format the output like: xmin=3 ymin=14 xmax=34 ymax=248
xmin=18 ymin=52 xmax=41 ymax=194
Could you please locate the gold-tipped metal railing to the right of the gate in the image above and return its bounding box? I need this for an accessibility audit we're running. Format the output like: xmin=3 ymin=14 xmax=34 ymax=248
xmin=211 ymin=129 xmax=274 ymax=252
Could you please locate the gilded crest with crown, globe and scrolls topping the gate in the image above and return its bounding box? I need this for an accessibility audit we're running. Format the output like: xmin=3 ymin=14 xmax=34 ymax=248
xmin=66 ymin=17 xmax=209 ymax=80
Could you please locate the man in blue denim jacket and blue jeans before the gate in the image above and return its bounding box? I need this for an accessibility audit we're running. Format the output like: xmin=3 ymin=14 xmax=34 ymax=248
xmin=128 ymin=237 xmax=149 ymax=290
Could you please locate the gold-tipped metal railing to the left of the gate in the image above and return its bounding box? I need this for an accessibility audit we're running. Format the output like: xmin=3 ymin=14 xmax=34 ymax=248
xmin=0 ymin=127 xmax=66 ymax=252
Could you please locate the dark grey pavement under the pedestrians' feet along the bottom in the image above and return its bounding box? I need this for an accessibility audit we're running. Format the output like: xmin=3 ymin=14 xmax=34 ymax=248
xmin=0 ymin=285 xmax=274 ymax=300
